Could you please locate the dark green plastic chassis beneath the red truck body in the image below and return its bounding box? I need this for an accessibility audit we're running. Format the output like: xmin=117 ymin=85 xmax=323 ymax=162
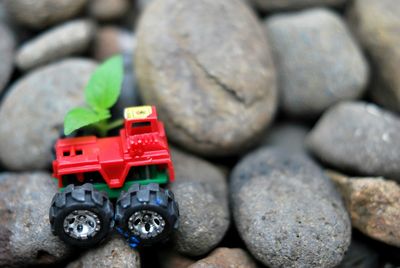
xmin=54 ymin=168 xmax=168 ymax=198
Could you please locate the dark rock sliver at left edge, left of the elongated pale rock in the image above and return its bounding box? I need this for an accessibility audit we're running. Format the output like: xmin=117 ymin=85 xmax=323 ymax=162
xmin=0 ymin=22 xmax=15 ymax=92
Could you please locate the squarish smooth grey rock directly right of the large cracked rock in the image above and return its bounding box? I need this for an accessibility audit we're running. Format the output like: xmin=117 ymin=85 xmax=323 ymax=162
xmin=265 ymin=8 xmax=368 ymax=117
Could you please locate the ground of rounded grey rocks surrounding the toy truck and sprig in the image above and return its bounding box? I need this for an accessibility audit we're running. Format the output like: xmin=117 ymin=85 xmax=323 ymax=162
xmin=0 ymin=0 xmax=400 ymax=268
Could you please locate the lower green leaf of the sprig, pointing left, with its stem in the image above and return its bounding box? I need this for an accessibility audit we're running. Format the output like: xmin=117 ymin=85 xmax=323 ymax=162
xmin=64 ymin=107 xmax=111 ymax=135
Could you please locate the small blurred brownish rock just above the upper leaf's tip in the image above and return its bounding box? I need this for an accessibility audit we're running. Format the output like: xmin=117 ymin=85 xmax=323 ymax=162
xmin=94 ymin=26 xmax=135 ymax=61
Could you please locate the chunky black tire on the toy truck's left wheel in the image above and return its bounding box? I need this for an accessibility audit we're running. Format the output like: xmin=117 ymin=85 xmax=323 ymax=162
xmin=49 ymin=183 xmax=114 ymax=247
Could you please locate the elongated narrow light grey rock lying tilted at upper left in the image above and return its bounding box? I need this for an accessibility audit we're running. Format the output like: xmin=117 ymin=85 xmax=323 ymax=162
xmin=16 ymin=20 xmax=95 ymax=71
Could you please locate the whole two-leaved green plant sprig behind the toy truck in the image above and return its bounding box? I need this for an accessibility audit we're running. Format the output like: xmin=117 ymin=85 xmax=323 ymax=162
xmin=64 ymin=55 xmax=124 ymax=136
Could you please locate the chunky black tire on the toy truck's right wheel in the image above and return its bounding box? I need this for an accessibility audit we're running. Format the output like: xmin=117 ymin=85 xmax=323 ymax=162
xmin=115 ymin=183 xmax=179 ymax=246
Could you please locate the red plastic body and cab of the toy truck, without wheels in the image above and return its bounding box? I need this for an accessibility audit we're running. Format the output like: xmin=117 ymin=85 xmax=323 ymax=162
xmin=53 ymin=106 xmax=174 ymax=195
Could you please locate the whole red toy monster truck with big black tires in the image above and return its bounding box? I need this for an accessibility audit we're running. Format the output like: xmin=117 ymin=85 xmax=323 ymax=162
xmin=50 ymin=106 xmax=179 ymax=247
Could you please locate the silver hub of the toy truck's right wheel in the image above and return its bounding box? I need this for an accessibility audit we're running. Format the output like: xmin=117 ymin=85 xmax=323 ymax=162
xmin=128 ymin=210 xmax=165 ymax=239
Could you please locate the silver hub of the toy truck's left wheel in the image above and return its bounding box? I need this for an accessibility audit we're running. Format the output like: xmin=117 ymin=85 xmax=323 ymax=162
xmin=64 ymin=210 xmax=100 ymax=240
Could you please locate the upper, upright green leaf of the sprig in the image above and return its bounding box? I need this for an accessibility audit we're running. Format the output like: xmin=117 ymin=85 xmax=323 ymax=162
xmin=85 ymin=55 xmax=124 ymax=111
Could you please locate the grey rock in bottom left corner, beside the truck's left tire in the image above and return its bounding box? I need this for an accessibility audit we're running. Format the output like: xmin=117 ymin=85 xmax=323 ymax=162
xmin=0 ymin=172 xmax=71 ymax=267
